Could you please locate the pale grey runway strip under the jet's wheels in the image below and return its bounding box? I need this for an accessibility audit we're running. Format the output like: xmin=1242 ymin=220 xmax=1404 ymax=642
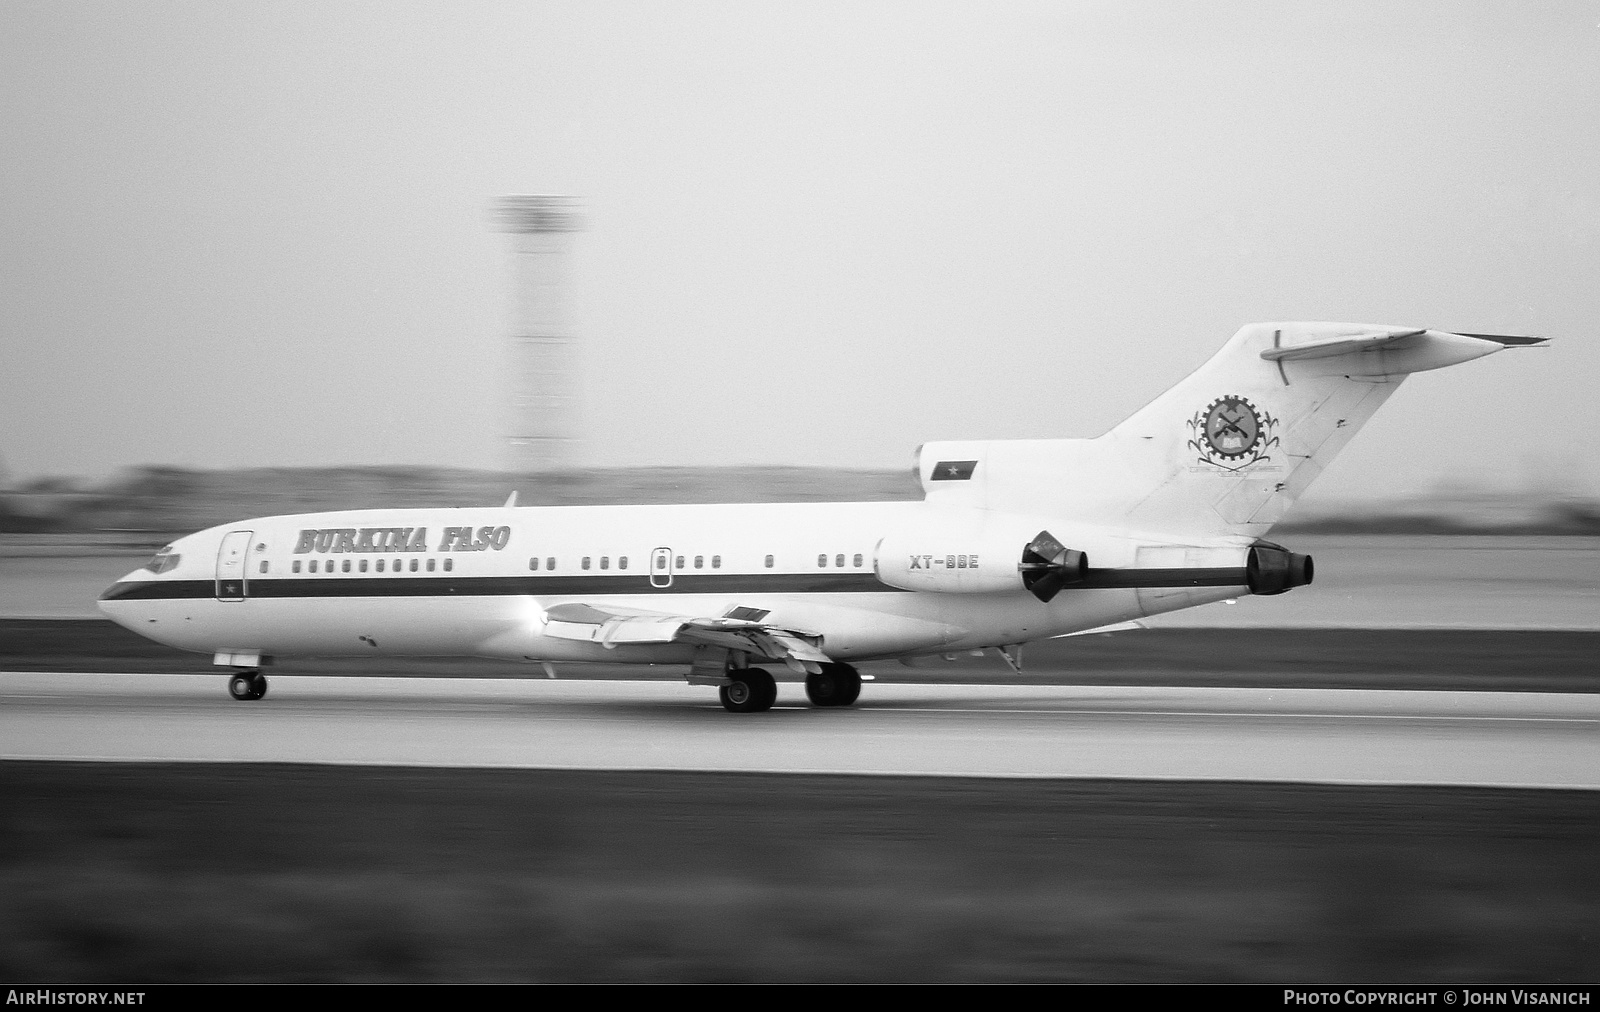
xmin=0 ymin=673 xmax=1600 ymax=789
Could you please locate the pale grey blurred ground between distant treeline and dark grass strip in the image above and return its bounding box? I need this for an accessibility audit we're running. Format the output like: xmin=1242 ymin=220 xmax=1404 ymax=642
xmin=0 ymin=535 xmax=1600 ymax=629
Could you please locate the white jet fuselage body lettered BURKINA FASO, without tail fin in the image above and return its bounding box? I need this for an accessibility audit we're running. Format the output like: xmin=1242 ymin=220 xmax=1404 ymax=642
xmin=101 ymin=501 xmax=1250 ymax=665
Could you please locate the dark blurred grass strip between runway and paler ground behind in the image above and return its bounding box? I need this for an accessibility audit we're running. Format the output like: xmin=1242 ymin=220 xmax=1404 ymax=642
xmin=0 ymin=618 xmax=1600 ymax=692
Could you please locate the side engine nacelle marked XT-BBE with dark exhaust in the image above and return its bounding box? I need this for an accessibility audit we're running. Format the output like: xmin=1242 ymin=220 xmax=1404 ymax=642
xmin=872 ymin=530 xmax=1088 ymax=600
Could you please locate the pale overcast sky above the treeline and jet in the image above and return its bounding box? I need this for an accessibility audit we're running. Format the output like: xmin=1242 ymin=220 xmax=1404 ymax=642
xmin=0 ymin=0 xmax=1600 ymax=496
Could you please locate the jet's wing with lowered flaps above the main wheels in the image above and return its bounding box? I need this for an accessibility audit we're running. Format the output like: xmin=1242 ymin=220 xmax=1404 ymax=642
xmin=544 ymin=602 xmax=830 ymax=674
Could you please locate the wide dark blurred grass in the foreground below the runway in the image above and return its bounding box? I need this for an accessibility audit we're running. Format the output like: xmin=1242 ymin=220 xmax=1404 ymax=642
xmin=0 ymin=762 xmax=1600 ymax=983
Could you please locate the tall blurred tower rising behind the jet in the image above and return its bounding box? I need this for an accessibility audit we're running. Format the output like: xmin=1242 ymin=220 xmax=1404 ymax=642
xmin=494 ymin=194 xmax=581 ymax=474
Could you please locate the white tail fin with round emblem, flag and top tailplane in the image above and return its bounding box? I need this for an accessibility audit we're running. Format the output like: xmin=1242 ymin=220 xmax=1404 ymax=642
xmin=920 ymin=323 xmax=1544 ymax=538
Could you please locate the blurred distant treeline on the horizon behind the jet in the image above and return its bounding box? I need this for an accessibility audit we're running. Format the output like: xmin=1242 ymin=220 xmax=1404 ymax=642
xmin=0 ymin=466 xmax=1600 ymax=541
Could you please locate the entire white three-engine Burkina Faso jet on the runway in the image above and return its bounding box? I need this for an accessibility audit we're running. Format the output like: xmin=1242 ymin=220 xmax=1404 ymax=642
xmin=99 ymin=323 xmax=1542 ymax=713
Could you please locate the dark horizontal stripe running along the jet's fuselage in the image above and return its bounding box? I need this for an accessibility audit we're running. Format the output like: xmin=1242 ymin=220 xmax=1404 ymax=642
xmin=101 ymin=567 xmax=1245 ymax=600
